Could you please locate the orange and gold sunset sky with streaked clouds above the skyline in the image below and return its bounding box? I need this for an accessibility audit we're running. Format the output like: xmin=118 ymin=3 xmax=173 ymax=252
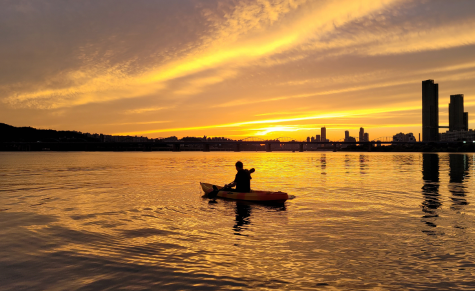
xmin=0 ymin=0 xmax=475 ymax=140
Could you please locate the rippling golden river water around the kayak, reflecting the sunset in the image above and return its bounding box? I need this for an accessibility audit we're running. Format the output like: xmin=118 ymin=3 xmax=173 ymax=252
xmin=0 ymin=152 xmax=475 ymax=290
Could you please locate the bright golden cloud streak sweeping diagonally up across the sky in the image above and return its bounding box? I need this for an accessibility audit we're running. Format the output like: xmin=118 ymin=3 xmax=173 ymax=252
xmin=6 ymin=0 xmax=397 ymax=108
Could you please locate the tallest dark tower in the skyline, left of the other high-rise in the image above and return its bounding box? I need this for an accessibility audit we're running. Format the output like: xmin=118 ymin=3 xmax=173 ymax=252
xmin=422 ymin=80 xmax=439 ymax=141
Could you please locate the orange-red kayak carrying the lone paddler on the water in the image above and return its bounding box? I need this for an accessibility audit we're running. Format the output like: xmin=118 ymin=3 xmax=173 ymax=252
xmin=200 ymin=182 xmax=289 ymax=203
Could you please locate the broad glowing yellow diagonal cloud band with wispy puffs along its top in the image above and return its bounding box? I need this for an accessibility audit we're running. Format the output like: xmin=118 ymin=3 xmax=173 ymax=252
xmin=1 ymin=1 xmax=404 ymax=108
